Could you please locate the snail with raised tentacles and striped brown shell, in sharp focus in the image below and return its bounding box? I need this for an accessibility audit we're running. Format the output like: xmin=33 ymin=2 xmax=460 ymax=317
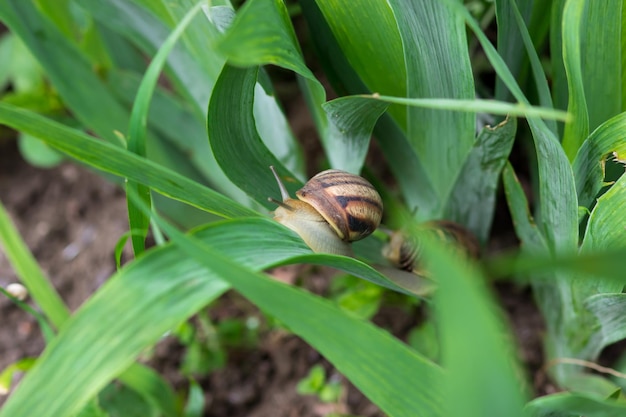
xmin=269 ymin=167 xmax=383 ymax=256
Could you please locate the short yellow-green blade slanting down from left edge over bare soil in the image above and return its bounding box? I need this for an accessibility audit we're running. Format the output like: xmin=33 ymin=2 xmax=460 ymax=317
xmin=0 ymin=203 xmax=70 ymax=328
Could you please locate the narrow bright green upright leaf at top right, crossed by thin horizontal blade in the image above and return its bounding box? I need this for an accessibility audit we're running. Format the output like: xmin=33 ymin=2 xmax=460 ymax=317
xmin=562 ymin=0 xmax=589 ymax=161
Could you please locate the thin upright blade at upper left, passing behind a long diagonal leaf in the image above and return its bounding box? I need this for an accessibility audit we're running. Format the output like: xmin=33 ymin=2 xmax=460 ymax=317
xmin=126 ymin=3 xmax=202 ymax=256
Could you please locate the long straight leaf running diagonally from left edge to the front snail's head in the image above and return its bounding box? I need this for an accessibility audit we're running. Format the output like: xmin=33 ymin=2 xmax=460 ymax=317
xmin=0 ymin=102 xmax=258 ymax=217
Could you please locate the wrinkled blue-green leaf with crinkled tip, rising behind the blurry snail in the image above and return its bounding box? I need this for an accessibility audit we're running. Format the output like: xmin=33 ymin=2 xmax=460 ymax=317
xmin=445 ymin=118 xmax=521 ymax=244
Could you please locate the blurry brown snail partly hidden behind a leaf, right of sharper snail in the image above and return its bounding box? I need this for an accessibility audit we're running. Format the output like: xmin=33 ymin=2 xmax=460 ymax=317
xmin=383 ymin=220 xmax=480 ymax=276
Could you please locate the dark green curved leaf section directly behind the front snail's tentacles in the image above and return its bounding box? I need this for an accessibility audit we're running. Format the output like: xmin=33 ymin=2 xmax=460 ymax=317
xmin=207 ymin=65 xmax=301 ymax=208
